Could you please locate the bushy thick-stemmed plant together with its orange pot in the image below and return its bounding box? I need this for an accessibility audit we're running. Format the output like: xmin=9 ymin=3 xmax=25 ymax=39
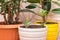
xmin=0 ymin=0 xmax=21 ymax=40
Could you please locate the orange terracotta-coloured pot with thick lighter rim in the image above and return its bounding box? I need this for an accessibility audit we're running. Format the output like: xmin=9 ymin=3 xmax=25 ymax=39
xmin=0 ymin=24 xmax=19 ymax=40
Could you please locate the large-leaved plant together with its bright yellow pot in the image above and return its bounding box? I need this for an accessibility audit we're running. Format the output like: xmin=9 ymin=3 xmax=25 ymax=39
xmin=23 ymin=0 xmax=60 ymax=40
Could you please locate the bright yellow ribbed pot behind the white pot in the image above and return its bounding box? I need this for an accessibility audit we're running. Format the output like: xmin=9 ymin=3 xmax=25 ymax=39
xmin=34 ymin=21 xmax=58 ymax=40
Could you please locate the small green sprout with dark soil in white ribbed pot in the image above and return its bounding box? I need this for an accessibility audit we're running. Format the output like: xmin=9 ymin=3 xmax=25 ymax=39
xmin=18 ymin=0 xmax=47 ymax=40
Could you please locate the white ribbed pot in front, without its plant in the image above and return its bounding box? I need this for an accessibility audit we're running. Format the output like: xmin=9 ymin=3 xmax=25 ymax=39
xmin=18 ymin=24 xmax=47 ymax=40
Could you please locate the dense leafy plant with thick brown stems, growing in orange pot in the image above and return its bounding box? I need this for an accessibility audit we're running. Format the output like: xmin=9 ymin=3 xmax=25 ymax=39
xmin=0 ymin=0 xmax=20 ymax=24
